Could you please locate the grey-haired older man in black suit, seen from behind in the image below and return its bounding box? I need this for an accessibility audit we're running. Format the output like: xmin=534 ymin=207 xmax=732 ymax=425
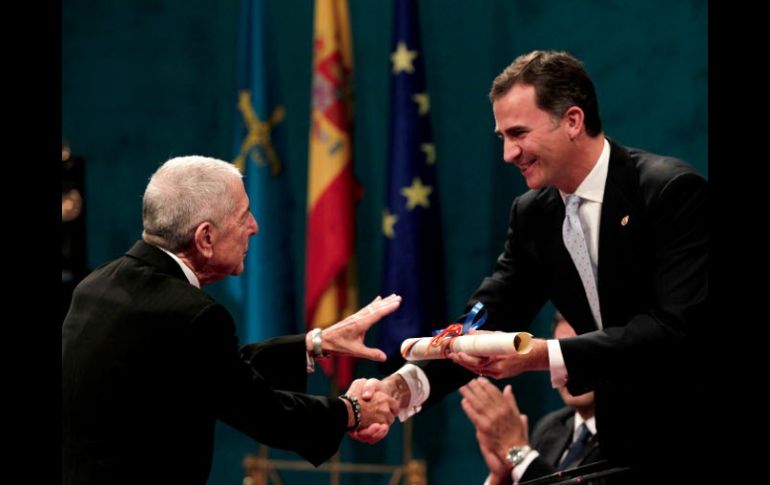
xmin=62 ymin=156 xmax=401 ymax=484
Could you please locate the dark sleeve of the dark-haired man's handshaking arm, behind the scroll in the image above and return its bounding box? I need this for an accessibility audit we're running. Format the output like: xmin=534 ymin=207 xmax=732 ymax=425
xmin=418 ymin=198 xmax=546 ymax=406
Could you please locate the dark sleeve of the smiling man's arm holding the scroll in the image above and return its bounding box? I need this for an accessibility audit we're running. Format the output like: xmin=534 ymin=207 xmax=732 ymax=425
xmin=560 ymin=173 xmax=708 ymax=395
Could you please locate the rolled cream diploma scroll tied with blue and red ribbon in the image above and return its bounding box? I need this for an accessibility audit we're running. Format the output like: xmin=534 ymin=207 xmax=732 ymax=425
xmin=401 ymin=332 xmax=532 ymax=360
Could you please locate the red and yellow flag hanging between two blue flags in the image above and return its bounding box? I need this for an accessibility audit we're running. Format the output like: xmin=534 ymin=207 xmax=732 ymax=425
xmin=305 ymin=0 xmax=359 ymax=389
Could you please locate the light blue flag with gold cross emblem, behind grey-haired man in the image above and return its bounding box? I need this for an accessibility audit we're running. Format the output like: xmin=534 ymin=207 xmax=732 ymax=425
xmin=228 ymin=0 xmax=297 ymax=343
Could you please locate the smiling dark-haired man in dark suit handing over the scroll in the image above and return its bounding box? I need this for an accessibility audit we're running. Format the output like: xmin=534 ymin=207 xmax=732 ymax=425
xmin=356 ymin=51 xmax=708 ymax=478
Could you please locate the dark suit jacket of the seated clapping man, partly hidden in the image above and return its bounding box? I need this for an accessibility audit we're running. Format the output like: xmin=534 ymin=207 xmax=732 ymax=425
xmin=521 ymin=407 xmax=602 ymax=482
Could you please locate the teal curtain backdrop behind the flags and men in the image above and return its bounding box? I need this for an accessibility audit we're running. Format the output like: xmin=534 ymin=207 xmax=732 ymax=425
xmin=62 ymin=0 xmax=708 ymax=485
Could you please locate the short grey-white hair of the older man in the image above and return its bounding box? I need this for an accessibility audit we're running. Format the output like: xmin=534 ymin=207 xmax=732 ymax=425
xmin=142 ymin=155 xmax=242 ymax=252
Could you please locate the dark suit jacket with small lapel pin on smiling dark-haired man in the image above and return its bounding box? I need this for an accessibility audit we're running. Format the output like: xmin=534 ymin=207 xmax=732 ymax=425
xmin=421 ymin=142 xmax=713 ymax=476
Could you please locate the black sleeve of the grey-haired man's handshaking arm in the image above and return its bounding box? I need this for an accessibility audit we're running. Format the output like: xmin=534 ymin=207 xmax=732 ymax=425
xmin=188 ymin=304 xmax=347 ymax=465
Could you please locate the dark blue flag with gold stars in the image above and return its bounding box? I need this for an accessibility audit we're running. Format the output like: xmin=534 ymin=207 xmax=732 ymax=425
xmin=378 ymin=0 xmax=447 ymax=357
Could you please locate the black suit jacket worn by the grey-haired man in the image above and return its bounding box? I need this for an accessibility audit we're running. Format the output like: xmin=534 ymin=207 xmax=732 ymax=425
xmin=62 ymin=241 xmax=347 ymax=484
